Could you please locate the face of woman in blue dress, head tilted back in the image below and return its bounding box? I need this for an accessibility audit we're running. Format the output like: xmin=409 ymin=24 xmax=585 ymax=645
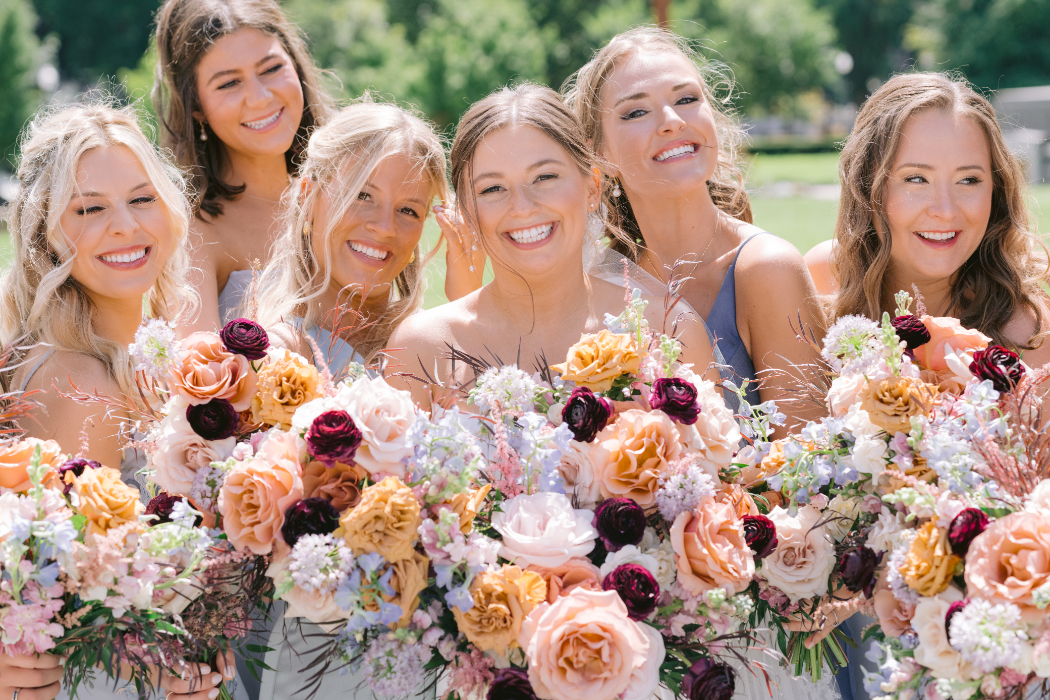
xmin=601 ymin=49 xmax=718 ymax=197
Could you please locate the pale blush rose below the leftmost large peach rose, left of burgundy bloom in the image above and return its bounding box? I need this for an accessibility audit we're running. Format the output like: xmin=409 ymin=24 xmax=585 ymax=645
xmin=149 ymin=407 xmax=237 ymax=496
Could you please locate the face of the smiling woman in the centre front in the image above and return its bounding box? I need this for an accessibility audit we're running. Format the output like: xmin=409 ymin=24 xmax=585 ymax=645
xmin=463 ymin=126 xmax=599 ymax=274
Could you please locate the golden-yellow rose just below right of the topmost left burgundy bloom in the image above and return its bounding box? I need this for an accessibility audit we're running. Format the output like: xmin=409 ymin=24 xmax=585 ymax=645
xmin=252 ymin=347 xmax=320 ymax=430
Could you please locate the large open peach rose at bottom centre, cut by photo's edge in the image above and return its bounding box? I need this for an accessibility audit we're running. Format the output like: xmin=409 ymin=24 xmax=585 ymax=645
xmin=521 ymin=588 xmax=665 ymax=700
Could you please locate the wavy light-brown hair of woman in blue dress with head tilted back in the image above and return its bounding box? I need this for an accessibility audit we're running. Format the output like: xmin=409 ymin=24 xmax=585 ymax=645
xmin=562 ymin=25 xmax=754 ymax=260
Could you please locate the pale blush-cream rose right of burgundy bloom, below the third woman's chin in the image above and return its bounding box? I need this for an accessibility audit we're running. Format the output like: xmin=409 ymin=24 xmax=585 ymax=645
xmin=347 ymin=377 xmax=416 ymax=479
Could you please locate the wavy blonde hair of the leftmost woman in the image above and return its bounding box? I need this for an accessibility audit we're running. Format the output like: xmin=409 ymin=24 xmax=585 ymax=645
xmin=0 ymin=99 xmax=197 ymax=401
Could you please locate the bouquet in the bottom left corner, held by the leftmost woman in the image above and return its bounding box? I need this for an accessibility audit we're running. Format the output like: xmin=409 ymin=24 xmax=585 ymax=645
xmin=0 ymin=439 xmax=254 ymax=696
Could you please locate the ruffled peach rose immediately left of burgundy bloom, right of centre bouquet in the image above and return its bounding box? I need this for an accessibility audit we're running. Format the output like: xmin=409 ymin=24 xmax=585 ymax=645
xmin=671 ymin=499 xmax=755 ymax=595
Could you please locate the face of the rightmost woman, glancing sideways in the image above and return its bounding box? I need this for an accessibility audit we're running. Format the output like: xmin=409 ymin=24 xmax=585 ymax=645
xmin=883 ymin=109 xmax=992 ymax=283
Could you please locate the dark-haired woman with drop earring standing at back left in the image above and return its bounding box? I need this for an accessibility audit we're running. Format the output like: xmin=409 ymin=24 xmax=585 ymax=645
xmin=153 ymin=0 xmax=332 ymax=332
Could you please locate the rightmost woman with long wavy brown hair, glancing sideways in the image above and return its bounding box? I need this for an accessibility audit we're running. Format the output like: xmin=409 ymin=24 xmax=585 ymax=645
xmin=806 ymin=72 xmax=1050 ymax=366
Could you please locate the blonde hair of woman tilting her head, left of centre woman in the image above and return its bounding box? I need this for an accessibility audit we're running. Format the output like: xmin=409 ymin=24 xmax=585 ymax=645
xmin=258 ymin=97 xmax=448 ymax=360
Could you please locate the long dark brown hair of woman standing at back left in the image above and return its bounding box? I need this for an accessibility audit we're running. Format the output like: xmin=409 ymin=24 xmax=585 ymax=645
xmin=152 ymin=0 xmax=332 ymax=216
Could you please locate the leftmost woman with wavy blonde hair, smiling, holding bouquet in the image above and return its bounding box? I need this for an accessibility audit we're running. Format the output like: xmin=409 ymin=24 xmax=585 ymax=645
xmin=0 ymin=104 xmax=234 ymax=700
